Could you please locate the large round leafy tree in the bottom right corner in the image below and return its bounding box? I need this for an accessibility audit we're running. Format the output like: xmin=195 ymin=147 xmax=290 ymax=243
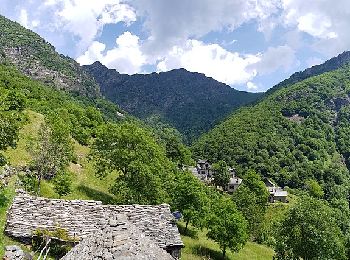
xmin=276 ymin=196 xmax=347 ymax=260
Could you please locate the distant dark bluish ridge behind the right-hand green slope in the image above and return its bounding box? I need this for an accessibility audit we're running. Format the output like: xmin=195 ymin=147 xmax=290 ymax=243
xmin=267 ymin=51 xmax=350 ymax=94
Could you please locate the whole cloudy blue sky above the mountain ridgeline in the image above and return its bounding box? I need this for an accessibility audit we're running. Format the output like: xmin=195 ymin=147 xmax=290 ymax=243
xmin=0 ymin=0 xmax=350 ymax=92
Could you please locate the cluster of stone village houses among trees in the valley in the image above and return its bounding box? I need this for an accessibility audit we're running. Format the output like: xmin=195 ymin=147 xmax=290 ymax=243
xmin=185 ymin=160 xmax=288 ymax=203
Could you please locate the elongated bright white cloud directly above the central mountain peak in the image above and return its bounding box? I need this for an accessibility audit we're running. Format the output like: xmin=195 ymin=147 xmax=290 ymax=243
xmin=157 ymin=40 xmax=260 ymax=85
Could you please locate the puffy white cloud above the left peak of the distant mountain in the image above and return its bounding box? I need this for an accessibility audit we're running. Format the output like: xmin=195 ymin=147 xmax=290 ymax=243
xmin=77 ymin=32 xmax=146 ymax=74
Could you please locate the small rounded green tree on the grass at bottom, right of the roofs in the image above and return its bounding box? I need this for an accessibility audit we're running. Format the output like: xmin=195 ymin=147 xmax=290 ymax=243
xmin=207 ymin=196 xmax=248 ymax=258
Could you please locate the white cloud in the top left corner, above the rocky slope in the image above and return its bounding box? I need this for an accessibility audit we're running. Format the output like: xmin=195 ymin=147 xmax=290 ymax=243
xmin=2 ymin=0 xmax=136 ymax=53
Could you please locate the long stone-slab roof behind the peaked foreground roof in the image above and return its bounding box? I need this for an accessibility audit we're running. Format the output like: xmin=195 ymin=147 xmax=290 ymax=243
xmin=5 ymin=193 xmax=183 ymax=248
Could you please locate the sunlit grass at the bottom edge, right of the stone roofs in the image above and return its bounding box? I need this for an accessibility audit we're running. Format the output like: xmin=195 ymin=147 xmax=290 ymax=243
xmin=178 ymin=222 xmax=274 ymax=260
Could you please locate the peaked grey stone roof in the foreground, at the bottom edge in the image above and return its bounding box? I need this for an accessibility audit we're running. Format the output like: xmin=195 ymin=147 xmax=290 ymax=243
xmin=62 ymin=219 xmax=174 ymax=260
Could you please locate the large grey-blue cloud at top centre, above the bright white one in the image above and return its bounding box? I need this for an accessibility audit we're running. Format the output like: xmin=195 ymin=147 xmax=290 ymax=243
xmin=130 ymin=0 xmax=280 ymax=53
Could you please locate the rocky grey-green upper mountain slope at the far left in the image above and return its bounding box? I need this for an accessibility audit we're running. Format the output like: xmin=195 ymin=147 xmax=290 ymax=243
xmin=0 ymin=15 xmax=99 ymax=97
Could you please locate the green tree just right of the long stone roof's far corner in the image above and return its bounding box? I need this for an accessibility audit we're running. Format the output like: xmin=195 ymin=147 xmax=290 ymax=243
xmin=172 ymin=171 xmax=208 ymax=232
